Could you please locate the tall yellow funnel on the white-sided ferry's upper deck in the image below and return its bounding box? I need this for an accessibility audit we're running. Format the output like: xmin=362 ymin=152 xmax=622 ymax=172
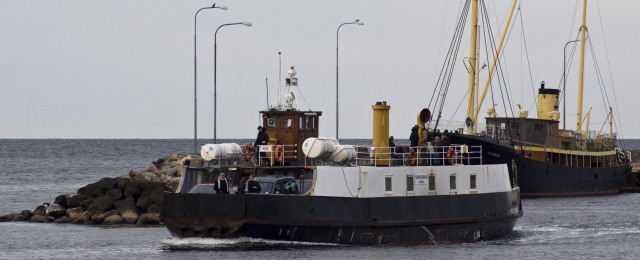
xmin=371 ymin=101 xmax=390 ymax=165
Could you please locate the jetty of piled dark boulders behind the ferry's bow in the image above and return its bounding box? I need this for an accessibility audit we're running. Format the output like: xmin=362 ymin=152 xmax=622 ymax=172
xmin=0 ymin=153 xmax=195 ymax=226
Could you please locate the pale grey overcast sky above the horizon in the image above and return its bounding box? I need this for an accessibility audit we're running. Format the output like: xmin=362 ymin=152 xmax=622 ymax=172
xmin=0 ymin=0 xmax=640 ymax=139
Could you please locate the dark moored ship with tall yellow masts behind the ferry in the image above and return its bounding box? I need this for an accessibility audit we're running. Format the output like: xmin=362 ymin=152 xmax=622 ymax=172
xmin=428 ymin=0 xmax=631 ymax=197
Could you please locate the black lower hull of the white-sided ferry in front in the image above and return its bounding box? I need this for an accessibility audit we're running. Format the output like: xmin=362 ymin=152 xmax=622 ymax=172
xmin=163 ymin=189 xmax=522 ymax=245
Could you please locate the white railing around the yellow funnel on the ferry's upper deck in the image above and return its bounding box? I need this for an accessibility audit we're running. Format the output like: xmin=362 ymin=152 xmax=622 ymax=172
xmin=353 ymin=144 xmax=482 ymax=167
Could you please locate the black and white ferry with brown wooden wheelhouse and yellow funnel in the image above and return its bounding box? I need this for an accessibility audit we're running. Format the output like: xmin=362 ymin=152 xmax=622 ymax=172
xmin=162 ymin=68 xmax=522 ymax=245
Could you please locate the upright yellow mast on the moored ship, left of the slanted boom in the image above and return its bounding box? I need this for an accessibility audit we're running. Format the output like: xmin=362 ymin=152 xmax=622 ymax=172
xmin=466 ymin=0 xmax=478 ymax=133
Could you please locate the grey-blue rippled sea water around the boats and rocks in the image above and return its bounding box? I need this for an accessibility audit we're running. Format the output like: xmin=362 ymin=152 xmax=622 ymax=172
xmin=0 ymin=139 xmax=640 ymax=259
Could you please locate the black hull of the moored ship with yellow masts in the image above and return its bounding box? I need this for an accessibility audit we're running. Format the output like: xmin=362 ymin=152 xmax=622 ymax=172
xmin=448 ymin=134 xmax=631 ymax=197
